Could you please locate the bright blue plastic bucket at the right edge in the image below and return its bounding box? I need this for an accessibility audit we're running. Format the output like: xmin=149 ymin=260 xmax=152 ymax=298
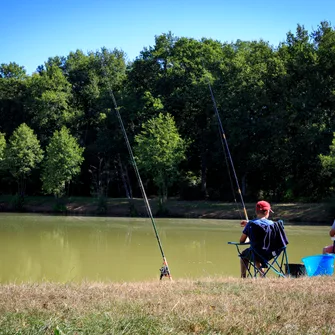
xmin=302 ymin=254 xmax=335 ymax=277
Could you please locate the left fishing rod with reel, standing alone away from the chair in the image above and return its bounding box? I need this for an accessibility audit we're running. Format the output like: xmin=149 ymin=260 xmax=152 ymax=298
xmin=110 ymin=90 xmax=172 ymax=280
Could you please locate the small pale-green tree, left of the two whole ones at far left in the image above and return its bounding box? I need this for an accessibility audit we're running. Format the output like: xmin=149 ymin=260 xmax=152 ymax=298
xmin=4 ymin=123 xmax=43 ymax=208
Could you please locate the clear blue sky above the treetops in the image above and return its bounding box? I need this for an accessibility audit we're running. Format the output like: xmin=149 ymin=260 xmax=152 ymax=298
xmin=0 ymin=0 xmax=335 ymax=74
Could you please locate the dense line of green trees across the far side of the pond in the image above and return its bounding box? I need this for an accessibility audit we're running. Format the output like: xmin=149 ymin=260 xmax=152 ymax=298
xmin=0 ymin=21 xmax=335 ymax=207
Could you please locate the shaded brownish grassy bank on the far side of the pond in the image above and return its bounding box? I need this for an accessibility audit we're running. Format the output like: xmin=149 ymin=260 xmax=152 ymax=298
xmin=0 ymin=195 xmax=335 ymax=224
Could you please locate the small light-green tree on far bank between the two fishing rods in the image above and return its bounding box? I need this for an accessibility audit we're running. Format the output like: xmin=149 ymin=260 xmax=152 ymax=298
xmin=135 ymin=113 xmax=187 ymax=205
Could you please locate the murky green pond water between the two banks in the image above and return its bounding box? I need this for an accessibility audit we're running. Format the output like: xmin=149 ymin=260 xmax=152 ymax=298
xmin=0 ymin=214 xmax=331 ymax=283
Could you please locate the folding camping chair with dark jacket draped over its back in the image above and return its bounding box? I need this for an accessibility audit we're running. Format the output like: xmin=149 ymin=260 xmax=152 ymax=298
xmin=228 ymin=220 xmax=289 ymax=277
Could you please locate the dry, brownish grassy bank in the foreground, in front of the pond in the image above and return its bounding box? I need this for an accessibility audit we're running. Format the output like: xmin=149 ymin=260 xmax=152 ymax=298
xmin=0 ymin=277 xmax=335 ymax=335
